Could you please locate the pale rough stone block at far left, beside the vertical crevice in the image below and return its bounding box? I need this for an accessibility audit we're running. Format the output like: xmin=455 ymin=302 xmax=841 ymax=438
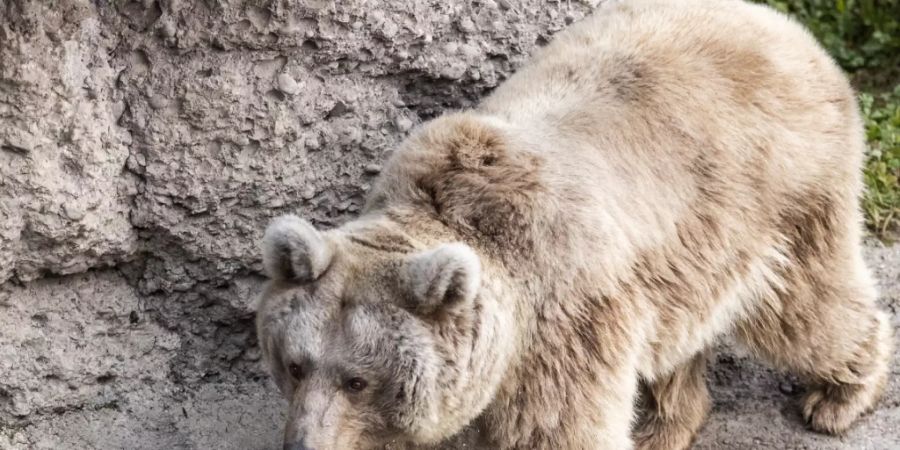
xmin=0 ymin=1 xmax=137 ymax=283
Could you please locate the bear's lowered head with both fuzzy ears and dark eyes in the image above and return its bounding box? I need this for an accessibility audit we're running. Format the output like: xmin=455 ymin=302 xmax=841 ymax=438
xmin=257 ymin=215 xmax=512 ymax=450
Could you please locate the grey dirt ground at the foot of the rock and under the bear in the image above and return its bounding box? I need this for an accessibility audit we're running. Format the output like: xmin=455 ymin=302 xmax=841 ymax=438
xmin=0 ymin=242 xmax=900 ymax=450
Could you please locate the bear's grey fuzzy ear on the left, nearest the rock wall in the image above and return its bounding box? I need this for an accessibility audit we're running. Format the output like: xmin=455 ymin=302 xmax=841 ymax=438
xmin=262 ymin=215 xmax=334 ymax=283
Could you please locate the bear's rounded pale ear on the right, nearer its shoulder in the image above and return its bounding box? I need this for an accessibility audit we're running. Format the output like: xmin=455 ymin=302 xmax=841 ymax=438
xmin=403 ymin=243 xmax=481 ymax=313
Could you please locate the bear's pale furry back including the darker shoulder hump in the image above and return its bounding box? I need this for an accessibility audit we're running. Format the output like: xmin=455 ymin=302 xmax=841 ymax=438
xmin=368 ymin=0 xmax=863 ymax=282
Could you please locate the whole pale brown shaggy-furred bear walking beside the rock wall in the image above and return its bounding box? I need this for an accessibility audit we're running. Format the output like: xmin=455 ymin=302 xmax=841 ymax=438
xmin=258 ymin=0 xmax=891 ymax=450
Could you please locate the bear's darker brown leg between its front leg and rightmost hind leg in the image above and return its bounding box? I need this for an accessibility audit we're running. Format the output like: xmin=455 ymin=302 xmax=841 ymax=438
xmin=634 ymin=353 xmax=710 ymax=450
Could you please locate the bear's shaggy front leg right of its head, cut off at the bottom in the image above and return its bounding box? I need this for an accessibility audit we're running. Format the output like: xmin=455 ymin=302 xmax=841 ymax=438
xmin=485 ymin=341 xmax=638 ymax=450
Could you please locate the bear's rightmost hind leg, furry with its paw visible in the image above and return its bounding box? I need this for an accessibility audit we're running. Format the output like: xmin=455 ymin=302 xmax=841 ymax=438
xmin=736 ymin=241 xmax=892 ymax=434
